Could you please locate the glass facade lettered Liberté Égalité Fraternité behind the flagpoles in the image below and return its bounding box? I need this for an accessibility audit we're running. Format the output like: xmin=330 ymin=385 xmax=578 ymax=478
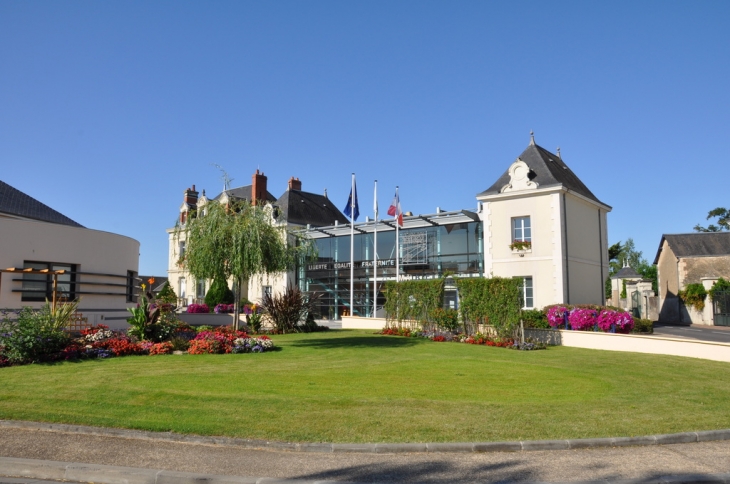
xmin=297 ymin=221 xmax=484 ymax=319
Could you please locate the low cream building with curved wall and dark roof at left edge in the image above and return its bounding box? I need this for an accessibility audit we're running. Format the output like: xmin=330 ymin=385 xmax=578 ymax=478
xmin=0 ymin=181 xmax=139 ymax=328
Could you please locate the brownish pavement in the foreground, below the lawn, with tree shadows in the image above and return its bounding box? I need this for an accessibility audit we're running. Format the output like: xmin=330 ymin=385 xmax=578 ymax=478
xmin=0 ymin=427 xmax=730 ymax=484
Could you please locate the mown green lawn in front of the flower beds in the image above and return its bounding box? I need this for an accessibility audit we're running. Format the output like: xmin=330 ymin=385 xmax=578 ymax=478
xmin=0 ymin=330 xmax=730 ymax=442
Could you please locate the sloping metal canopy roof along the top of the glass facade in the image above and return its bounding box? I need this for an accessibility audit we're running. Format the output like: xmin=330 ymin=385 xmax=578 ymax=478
xmin=303 ymin=210 xmax=479 ymax=239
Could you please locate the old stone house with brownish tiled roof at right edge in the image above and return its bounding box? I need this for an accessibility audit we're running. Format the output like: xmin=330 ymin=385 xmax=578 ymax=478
xmin=654 ymin=232 xmax=730 ymax=324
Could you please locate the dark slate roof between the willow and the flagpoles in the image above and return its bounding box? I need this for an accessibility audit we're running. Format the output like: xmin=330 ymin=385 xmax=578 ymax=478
xmin=274 ymin=189 xmax=350 ymax=227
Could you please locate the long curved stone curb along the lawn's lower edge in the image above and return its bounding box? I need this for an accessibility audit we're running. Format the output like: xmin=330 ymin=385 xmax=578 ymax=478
xmin=0 ymin=420 xmax=730 ymax=454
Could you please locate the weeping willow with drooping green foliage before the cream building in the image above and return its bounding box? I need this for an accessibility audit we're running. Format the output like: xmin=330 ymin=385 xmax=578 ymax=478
xmin=175 ymin=201 xmax=311 ymax=328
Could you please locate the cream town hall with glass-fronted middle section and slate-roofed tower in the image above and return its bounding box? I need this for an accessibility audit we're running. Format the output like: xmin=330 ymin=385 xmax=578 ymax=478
xmin=168 ymin=138 xmax=611 ymax=319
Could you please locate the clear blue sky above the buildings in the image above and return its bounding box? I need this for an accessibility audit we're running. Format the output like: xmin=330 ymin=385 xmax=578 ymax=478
xmin=0 ymin=0 xmax=730 ymax=275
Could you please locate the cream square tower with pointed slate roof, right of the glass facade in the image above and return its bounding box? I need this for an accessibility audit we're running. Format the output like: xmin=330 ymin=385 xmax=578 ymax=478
xmin=477 ymin=133 xmax=611 ymax=308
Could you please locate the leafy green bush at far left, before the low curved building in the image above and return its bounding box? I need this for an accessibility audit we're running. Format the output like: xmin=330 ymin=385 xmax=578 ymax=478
xmin=0 ymin=304 xmax=70 ymax=363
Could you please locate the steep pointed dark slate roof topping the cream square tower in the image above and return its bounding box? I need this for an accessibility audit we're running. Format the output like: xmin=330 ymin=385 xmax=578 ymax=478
xmin=477 ymin=143 xmax=606 ymax=205
